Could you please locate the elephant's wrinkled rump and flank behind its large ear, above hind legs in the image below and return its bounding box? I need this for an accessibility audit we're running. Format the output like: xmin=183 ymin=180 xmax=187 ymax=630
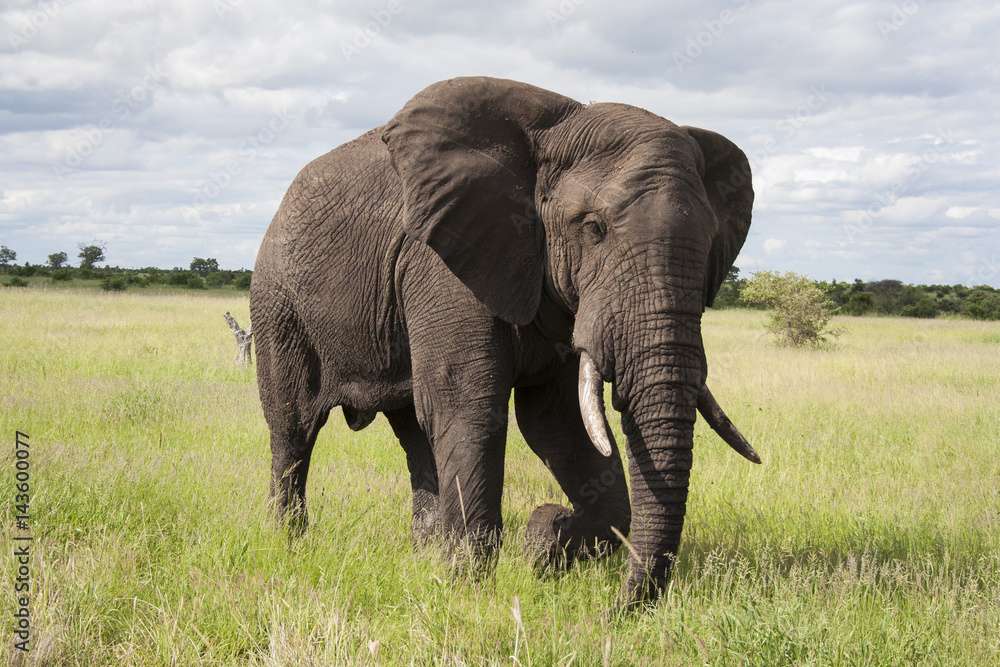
xmin=251 ymin=123 xmax=409 ymax=407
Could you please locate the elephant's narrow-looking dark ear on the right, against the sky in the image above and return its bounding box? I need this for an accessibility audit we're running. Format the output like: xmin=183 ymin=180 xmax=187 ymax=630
xmin=682 ymin=127 xmax=753 ymax=306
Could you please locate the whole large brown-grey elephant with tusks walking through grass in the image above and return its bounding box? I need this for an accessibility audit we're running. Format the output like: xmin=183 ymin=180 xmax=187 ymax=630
xmin=250 ymin=77 xmax=760 ymax=611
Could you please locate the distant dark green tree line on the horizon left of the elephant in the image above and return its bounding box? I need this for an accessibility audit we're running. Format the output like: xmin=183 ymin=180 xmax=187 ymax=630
xmin=0 ymin=241 xmax=253 ymax=291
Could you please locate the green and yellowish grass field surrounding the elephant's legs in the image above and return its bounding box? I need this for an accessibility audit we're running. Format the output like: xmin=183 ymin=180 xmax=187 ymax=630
xmin=0 ymin=288 xmax=1000 ymax=666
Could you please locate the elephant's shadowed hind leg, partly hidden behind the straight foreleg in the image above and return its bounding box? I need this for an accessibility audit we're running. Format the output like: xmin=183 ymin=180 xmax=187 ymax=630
xmin=385 ymin=405 xmax=441 ymax=543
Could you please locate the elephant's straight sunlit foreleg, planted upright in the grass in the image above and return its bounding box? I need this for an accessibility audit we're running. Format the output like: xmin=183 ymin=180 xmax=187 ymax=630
xmin=401 ymin=258 xmax=515 ymax=569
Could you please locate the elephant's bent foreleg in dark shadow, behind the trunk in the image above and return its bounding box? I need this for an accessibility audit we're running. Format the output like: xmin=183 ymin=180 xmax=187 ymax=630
xmin=514 ymin=363 xmax=631 ymax=566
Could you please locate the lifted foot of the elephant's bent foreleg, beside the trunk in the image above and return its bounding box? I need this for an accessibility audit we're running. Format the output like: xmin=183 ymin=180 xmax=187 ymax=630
xmin=524 ymin=503 xmax=621 ymax=571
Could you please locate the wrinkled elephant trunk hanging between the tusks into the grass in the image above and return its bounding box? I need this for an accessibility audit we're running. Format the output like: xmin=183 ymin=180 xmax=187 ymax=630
xmin=615 ymin=312 xmax=706 ymax=609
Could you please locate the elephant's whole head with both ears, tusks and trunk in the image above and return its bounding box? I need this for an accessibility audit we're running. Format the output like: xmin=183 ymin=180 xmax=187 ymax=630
xmin=383 ymin=78 xmax=756 ymax=607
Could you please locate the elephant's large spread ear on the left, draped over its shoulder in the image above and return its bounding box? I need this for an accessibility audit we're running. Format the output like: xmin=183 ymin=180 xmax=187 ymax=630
xmin=382 ymin=77 xmax=580 ymax=324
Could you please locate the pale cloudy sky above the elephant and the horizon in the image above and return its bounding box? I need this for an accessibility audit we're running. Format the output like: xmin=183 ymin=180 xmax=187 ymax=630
xmin=0 ymin=0 xmax=1000 ymax=287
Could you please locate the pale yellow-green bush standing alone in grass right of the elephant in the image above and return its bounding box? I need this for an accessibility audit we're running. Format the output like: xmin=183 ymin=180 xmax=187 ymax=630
xmin=742 ymin=271 xmax=837 ymax=347
